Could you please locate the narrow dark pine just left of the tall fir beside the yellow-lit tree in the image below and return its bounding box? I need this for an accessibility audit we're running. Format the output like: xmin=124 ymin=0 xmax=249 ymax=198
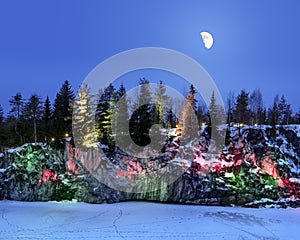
xmin=41 ymin=96 xmax=53 ymax=142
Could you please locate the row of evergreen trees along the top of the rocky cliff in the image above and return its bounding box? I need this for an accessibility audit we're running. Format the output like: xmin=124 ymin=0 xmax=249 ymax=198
xmin=0 ymin=78 xmax=300 ymax=150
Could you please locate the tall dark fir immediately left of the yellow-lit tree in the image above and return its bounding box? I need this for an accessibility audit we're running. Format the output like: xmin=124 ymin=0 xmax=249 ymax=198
xmin=53 ymin=80 xmax=75 ymax=139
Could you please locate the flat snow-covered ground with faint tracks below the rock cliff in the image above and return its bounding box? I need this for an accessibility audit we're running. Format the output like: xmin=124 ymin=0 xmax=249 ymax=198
xmin=0 ymin=201 xmax=300 ymax=240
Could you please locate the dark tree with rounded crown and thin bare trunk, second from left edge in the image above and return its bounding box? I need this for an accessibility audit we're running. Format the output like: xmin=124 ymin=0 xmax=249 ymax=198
xmin=23 ymin=94 xmax=43 ymax=142
